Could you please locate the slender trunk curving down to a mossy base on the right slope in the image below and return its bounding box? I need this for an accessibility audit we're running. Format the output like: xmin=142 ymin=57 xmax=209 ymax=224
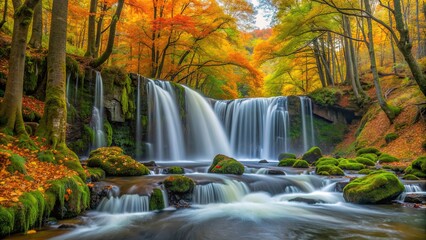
xmin=364 ymin=0 xmax=396 ymax=124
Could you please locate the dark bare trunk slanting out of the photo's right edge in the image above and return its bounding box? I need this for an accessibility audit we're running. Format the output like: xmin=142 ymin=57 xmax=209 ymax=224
xmin=393 ymin=0 xmax=426 ymax=96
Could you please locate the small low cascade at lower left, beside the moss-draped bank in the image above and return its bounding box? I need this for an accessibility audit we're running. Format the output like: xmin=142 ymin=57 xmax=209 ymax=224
xmin=96 ymin=194 xmax=149 ymax=214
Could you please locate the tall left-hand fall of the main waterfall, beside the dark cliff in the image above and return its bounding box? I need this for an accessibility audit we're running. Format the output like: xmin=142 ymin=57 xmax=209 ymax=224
xmin=148 ymin=80 xmax=185 ymax=160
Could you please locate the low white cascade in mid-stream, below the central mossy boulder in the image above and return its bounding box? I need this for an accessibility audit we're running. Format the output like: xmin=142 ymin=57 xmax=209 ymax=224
xmin=192 ymin=180 xmax=250 ymax=204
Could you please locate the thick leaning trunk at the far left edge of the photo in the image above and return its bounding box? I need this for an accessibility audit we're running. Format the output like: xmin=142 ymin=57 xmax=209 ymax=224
xmin=0 ymin=0 xmax=39 ymax=135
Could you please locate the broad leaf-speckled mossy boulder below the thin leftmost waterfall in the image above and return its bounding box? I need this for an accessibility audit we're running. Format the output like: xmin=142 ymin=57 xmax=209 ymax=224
xmin=87 ymin=147 xmax=149 ymax=176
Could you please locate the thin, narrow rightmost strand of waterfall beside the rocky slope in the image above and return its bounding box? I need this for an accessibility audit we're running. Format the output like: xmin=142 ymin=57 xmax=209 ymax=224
xmin=299 ymin=96 xmax=315 ymax=152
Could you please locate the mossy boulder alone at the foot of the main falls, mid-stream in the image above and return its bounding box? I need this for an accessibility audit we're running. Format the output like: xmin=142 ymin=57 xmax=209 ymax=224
xmin=208 ymin=154 xmax=244 ymax=175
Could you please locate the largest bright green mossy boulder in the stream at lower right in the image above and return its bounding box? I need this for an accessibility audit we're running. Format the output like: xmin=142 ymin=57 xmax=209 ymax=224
xmin=343 ymin=171 xmax=404 ymax=204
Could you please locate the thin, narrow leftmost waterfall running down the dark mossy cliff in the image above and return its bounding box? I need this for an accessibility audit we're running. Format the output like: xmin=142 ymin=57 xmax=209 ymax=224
xmin=90 ymin=71 xmax=106 ymax=149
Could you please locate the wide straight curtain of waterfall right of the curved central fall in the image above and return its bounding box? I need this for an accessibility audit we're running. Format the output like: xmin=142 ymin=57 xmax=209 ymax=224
xmin=214 ymin=97 xmax=290 ymax=159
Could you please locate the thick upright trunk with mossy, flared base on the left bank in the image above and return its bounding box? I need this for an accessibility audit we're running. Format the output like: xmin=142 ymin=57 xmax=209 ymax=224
xmin=37 ymin=0 xmax=68 ymax=149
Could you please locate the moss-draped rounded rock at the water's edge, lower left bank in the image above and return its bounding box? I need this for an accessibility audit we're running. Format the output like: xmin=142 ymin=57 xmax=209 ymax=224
xmin=46 ymin=175 xmax=90 ymax=218
